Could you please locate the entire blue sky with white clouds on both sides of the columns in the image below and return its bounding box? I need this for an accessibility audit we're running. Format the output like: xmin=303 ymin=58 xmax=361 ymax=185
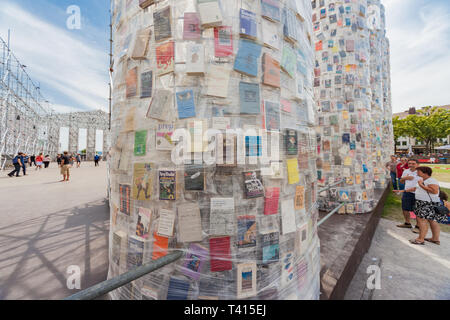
xmin=0 ymin=0 xmax=450 ymax=112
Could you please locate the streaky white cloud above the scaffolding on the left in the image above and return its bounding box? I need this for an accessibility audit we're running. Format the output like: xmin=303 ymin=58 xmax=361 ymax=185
xmin=0 ymin=3 xmax=108 ymax=111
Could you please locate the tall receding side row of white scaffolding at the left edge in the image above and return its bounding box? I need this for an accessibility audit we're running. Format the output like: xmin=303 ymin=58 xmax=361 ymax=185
xmin=0 ymin=34 xmax=59 ymax=170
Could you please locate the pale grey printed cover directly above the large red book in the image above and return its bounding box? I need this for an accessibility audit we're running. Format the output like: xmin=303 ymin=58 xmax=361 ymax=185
xmin=209 ymin=198 xmax=235 ymax=236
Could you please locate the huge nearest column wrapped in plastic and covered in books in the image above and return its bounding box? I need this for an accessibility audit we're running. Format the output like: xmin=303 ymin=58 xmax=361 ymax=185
xmin=109 ymin=0 xmax=320 ymax=300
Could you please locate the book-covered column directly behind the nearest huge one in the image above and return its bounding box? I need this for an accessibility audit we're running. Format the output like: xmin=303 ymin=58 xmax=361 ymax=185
xmin=312 ymin=0 xmax=375 ymax=214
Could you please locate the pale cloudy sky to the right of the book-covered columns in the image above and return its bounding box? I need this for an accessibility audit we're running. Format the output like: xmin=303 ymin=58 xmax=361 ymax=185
xmin=384 ymin=0 xmax=450 ymax=112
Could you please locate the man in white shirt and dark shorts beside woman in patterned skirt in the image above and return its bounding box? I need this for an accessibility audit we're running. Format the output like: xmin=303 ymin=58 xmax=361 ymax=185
xmin=394 ymin=159 xmax=419 ymax=232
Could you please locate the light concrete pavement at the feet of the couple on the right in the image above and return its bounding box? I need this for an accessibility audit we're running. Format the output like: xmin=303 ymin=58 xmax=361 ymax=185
xmin=345 ymin=219 xmax=450 ymax=300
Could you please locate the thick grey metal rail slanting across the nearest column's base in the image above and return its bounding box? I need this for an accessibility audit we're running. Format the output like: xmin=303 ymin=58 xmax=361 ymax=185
xmin=64 ymin=250 xmax=183 ymax=300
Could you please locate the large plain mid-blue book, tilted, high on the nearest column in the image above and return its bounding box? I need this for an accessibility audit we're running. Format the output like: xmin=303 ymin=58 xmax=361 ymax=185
xmin=234 ymin=39 xmax=262 ymax=77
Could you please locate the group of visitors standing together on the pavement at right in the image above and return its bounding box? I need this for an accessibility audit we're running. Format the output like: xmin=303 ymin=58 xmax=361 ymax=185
xmin=386 ymin=156 xmax=450 ymax=245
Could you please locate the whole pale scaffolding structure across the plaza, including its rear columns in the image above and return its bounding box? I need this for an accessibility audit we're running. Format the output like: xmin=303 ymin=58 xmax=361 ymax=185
xmin=0 ymin=32 xmax=109 ymax=171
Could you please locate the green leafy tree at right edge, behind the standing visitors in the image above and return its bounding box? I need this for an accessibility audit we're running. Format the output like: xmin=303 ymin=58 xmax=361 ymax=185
xmin=400 ymin=107 xmax=450 ymax=153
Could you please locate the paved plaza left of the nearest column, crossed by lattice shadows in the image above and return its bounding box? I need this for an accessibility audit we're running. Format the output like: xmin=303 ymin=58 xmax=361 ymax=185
xmin=0 ymin=163 xmax=109 ymax=300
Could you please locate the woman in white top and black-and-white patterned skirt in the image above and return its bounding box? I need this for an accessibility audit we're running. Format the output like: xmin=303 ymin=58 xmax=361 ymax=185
xmin=410 ymin=167 xmax=447 ymax=245
